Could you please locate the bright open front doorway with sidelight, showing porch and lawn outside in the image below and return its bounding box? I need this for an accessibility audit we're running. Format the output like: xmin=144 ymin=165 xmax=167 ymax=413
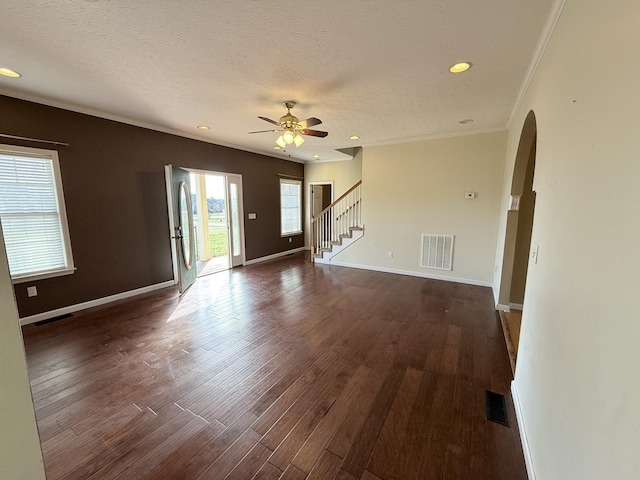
xmin=190 ymin=171 xmax=244 ymax=277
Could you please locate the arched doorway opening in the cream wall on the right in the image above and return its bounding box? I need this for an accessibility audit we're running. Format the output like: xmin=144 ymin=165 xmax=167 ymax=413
xmin=498 ymin=111 xmax=538 ymax=373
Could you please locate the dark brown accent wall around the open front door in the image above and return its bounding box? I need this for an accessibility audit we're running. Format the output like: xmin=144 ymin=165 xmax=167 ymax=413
xmin=0 ymin=96 xmax=304 ymax=317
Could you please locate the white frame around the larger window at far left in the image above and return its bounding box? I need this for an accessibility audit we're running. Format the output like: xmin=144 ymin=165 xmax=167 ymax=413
xmin=0 ymin=144 xmax=76 ymax=284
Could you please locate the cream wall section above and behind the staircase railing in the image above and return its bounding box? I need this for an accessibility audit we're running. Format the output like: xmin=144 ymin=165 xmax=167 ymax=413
xmin=304 ymin=148 xmax=362 ymax=248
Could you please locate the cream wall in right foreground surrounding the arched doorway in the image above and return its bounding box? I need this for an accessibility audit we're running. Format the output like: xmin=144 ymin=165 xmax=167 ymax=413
xmin=496 ymin=0 xmax=640 ymax=480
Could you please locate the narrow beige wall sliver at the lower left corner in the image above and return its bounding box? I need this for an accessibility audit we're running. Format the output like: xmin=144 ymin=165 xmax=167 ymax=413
xmin=0 ymin=230 xmax=45 ymax=480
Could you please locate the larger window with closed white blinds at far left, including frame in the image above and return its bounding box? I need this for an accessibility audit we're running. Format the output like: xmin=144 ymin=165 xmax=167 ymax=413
xmin=0 ymin=145 xmax=74 ymax=283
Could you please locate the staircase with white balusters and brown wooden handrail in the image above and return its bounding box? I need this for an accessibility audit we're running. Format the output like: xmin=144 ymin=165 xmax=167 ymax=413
xmin=311 ymin=180 xmax=364 ymax=263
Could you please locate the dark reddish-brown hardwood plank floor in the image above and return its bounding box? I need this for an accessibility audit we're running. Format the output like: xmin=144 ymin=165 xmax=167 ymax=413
xmin=23 ymin=254 xmax=526 ymax=480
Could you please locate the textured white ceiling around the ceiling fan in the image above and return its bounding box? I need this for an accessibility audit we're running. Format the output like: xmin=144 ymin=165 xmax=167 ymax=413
xmin=0 ymin=0 xmax=554 ymax=161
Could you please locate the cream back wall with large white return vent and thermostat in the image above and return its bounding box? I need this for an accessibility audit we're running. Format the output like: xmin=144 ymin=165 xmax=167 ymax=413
xmin=332 ymin=131 xmax=507 ymax=285
